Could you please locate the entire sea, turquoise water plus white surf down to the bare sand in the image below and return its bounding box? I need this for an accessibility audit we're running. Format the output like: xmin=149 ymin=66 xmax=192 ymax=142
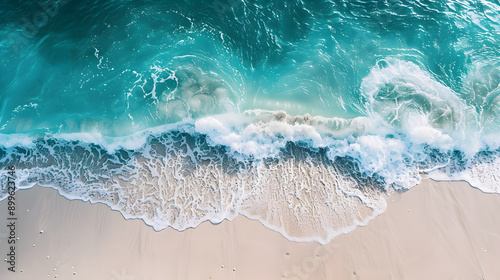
xmin=0 ymin=0 xmax=500 ymax=241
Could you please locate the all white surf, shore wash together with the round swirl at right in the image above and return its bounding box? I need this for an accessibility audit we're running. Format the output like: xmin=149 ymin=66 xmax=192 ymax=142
xmin=0 ymin=59 xmax=500 ymax=243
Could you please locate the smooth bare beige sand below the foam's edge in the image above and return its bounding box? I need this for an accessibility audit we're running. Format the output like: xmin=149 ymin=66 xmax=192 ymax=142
xmin=0 ymin=180 xmax=500 ymax=280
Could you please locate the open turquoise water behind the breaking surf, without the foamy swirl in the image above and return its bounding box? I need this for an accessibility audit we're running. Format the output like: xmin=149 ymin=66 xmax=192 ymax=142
xmin=0 ymin=1 xmax=500 ymax=136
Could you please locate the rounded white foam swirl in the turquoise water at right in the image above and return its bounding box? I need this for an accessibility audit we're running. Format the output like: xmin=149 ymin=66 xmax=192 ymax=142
xmin=361 ymin=58 xmax=484 ymax=156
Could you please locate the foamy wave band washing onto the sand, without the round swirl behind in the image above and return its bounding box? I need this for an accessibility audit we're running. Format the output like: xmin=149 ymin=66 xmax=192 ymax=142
xmin=0 ymin=108 xmax=500 ymax=243
